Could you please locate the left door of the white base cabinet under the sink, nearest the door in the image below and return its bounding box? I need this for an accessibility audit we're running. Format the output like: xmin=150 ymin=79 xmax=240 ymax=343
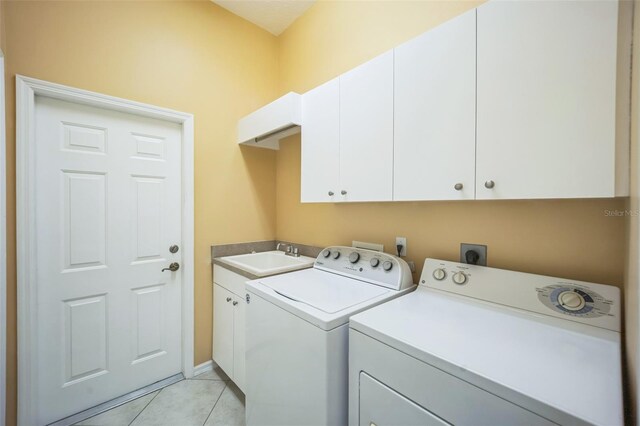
xmin=213 ymin=284 xmax=234 ymax=378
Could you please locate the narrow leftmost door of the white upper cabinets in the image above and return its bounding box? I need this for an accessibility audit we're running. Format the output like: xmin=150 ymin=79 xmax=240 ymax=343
xmin=300 ymin=79 xmax=340 ymax=203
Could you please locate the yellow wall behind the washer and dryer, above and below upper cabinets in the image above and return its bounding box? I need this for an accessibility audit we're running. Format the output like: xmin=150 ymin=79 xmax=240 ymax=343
xmin=276 ymin=0 xmax=625 ymax=286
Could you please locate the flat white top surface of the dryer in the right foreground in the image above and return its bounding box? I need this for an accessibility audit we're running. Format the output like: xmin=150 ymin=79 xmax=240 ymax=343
xmin=350 ymin=286 xmax=623 ymax=425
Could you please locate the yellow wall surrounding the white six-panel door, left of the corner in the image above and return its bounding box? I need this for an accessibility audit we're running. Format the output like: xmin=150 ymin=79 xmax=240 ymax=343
xmin=2 ymin=1 xmax=277 ymax=425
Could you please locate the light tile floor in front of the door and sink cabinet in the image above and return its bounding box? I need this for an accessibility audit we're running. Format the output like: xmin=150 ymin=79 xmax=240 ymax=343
xmin=76 ymin=366 xmax=245 ymax=426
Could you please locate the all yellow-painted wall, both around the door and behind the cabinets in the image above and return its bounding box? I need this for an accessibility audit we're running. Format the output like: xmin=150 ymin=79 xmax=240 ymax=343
xmin=0 ymin=0 xmax=636 ymax=425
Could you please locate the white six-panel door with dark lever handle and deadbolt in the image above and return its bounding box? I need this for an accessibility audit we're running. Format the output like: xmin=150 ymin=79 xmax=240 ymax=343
xmin=33 ymin=97 xmax=181 ymax=424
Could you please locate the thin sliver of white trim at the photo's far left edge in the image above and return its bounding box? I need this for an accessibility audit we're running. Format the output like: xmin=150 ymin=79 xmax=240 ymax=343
xmin=0 ymin=50 xmax=7 ymax=426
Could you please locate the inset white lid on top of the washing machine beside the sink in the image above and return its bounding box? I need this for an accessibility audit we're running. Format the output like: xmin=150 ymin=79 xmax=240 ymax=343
xmin=261 ymin=271 xmax=389 ymax=314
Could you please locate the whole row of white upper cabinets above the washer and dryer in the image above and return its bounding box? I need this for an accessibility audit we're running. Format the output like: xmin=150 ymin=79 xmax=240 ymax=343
xmin=301 ymin=0 xmax=631 ymax=202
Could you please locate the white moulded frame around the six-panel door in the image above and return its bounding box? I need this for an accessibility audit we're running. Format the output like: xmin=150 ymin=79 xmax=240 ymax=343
xmin=16 ymin=75 xmax=194 ymax=425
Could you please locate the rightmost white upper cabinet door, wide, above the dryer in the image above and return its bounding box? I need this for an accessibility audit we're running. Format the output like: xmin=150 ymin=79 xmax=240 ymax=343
xmin=476 ymin=1 xmax=618 ymax=199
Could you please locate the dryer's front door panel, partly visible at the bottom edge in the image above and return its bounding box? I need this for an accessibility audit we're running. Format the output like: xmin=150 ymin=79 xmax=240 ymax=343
xmin=359 ymin=372 xmax=450 ymax=426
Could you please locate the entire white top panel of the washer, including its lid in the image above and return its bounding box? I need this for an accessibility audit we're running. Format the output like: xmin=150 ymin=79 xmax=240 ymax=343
xmin=246 ymin=268 xmax=415 ymax=331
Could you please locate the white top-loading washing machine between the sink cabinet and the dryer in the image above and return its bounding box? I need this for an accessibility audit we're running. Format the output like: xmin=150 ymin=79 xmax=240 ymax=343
xmin=246 ymin=247 xmax=415 ymax=426
